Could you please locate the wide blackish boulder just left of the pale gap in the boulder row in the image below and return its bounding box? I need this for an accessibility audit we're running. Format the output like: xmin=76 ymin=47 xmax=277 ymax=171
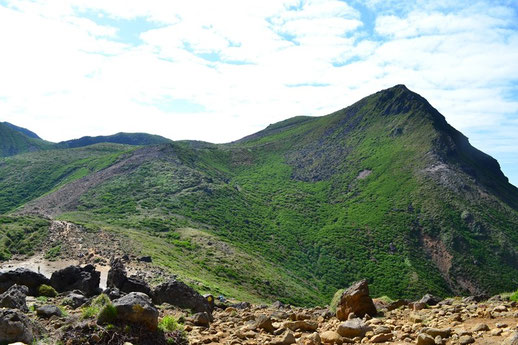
xmin=50 ymin=265 xmax=101 ymax=297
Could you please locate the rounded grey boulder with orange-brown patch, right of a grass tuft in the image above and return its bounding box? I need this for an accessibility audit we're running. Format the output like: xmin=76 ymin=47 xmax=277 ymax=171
xmin=113 ymin=292 xmax=158 ymax=331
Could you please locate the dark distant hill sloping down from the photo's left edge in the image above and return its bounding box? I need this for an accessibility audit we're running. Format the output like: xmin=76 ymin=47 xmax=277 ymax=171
xmin=0 ymin=122 xmax=52 ymax=157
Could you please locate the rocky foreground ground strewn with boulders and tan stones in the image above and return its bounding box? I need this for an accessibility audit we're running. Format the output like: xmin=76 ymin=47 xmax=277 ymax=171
xmin=0 ymin=259 xmax=518 ymax=345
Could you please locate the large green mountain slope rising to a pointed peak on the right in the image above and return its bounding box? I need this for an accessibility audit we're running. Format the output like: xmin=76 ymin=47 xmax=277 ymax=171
xmin=0 ymin=85 xmax=518 ymax=304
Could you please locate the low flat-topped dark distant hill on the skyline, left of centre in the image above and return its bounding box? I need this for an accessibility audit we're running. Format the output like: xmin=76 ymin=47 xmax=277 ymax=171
xmin=57 ymin=133 xmax=172 ymax=148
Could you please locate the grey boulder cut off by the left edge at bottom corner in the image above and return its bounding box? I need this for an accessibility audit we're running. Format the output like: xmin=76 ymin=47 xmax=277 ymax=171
xmin=0 ymin=309 xmax=38 ymax=344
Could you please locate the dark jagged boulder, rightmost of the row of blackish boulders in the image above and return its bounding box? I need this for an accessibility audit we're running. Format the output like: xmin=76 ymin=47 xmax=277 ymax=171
xmin=152 ymin=279 xmax=212 ymax=314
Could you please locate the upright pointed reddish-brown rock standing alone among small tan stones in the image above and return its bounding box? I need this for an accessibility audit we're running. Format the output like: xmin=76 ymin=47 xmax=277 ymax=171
xmin=336 ymin=280 xmax=377 ymax=321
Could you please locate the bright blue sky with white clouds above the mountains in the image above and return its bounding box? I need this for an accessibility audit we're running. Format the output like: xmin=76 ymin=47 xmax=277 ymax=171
xmin=0 ymin=0 xmax=518 ymax=185
